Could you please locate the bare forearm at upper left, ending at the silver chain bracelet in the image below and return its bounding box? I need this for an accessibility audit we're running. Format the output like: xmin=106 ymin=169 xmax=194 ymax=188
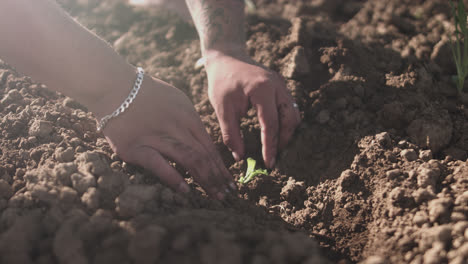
xmin=0 ymin=0 xmax=135 ymax=117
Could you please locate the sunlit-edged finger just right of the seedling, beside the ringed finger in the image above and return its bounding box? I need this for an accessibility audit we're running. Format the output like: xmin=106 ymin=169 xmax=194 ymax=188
xmin=252 ymin=97 xmax=278 ymax=169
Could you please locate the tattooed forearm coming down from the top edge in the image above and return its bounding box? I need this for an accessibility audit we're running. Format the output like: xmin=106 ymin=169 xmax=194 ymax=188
xmin=186 ymin=0 xmax=245 ymax=52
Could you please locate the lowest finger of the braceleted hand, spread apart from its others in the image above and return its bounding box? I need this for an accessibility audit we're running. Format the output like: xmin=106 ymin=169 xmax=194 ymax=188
xmin=134 ymin=147 xmax=190 ymax=193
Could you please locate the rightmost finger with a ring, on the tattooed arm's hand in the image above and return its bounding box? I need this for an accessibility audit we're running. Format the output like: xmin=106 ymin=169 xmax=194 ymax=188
xmin=278 ymin=92 xmax=300 ymax=149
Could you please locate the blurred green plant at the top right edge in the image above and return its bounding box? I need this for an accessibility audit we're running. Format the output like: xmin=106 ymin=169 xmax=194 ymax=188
xmin=450 ymin=0 xmax=468 ymax=94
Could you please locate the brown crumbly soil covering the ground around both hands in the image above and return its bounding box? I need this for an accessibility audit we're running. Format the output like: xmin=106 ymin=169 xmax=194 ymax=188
xmin=0 ymin=0 xmax=468 ymax=264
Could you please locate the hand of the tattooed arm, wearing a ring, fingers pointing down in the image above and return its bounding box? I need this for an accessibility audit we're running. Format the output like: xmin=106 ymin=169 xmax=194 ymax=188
xmin=205 ymin=52 xmax=300 ymax=168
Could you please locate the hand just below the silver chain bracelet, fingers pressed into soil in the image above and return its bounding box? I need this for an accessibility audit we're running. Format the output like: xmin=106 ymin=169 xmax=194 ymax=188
xmin=103 ymin=73 xmax=236 ymax=199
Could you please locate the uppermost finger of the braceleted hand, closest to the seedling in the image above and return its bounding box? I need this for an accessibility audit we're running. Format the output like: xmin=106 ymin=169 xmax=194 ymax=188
xmin=192 ymin=122 xmax=237 ymax=191
